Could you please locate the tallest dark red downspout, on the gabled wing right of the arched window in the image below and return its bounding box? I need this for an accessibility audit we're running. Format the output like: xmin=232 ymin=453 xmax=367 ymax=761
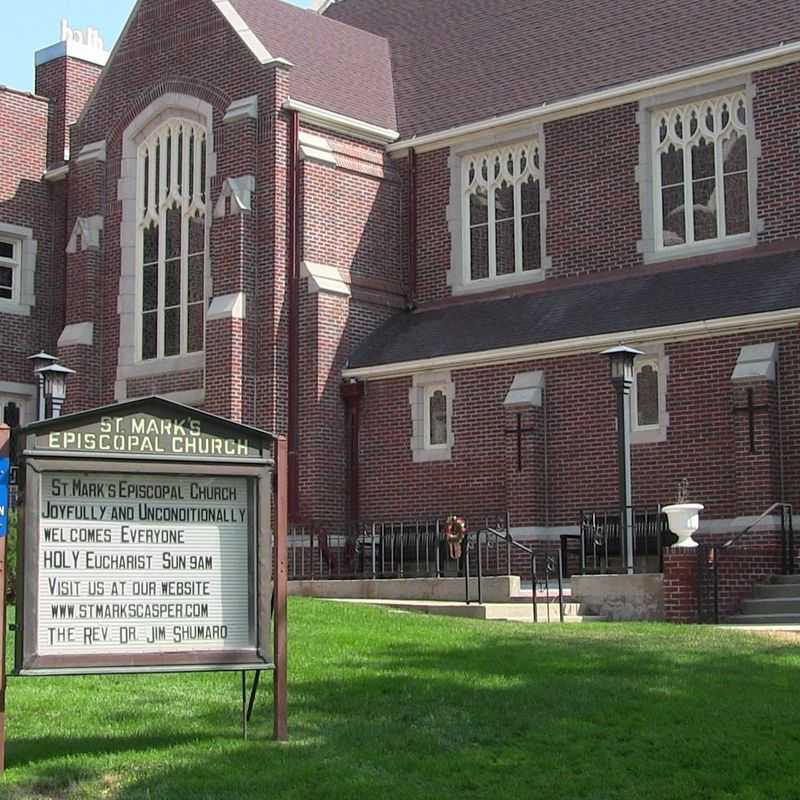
xmin=286 ymin=111 xmax=300 ymax=519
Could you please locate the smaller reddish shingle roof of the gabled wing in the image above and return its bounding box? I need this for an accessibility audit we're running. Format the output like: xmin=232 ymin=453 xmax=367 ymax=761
xmin=231 ymin=0 xmax=397 ymax=130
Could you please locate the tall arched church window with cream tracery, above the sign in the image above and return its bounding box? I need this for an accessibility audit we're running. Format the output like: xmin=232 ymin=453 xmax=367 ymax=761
xmin=136 ymin=118 xmax=208 ymax=361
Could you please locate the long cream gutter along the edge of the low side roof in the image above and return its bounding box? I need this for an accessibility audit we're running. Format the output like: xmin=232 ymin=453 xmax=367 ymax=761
xmin=342 ymin=308 xmax=800 ymax=380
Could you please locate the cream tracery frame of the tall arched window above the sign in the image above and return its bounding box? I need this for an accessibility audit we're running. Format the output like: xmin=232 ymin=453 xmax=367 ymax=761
xmin=136 ymin=115 xmax=211 ymax=364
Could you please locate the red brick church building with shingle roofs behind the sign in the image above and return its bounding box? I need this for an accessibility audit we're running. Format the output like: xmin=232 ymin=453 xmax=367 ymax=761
xmin=0 ymin=0 xmax=800 ymax=619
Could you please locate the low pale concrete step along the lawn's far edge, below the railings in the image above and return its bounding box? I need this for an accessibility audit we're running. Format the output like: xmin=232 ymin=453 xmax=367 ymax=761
xmin=324 ymin=598 xmax=605 ymax=623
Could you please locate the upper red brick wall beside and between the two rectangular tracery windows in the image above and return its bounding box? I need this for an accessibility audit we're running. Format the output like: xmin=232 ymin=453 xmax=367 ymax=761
xmin=410 ymin=64 xmax=800 ymax=303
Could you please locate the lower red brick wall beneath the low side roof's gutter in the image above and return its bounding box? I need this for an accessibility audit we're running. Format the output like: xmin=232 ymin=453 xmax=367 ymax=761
xmin=361 ymin=329 xmax=800 ymax=525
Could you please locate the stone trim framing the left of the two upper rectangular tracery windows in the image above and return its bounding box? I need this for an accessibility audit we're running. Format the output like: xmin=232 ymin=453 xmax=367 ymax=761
xmin=447 ymin=123 xmax=552 ymax=295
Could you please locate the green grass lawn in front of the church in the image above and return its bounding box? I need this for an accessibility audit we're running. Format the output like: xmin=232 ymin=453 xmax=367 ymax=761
xmin=0 ymin=599 xmax=800 ymax=800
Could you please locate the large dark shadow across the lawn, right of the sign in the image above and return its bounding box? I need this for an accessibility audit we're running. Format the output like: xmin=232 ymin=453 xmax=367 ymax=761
xmin=31 ymin=628 xmax=800 ymax=800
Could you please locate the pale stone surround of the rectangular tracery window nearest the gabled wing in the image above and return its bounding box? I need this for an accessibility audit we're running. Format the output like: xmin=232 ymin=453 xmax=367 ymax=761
xmin=447 ymin=124 xmax=551 ymax=295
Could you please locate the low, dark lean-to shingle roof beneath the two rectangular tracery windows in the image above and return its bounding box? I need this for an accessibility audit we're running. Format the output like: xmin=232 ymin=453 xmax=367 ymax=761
xmin=349 ymin=253 xmax=800 ymax=369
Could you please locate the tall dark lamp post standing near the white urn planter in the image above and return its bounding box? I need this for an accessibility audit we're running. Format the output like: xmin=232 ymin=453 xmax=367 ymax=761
xmin=603 ymin=345 xmax=642 ymax=575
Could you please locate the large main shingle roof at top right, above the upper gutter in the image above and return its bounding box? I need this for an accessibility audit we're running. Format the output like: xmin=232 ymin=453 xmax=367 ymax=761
xmin=325 ymin=0 xmax=800 ymax=137
